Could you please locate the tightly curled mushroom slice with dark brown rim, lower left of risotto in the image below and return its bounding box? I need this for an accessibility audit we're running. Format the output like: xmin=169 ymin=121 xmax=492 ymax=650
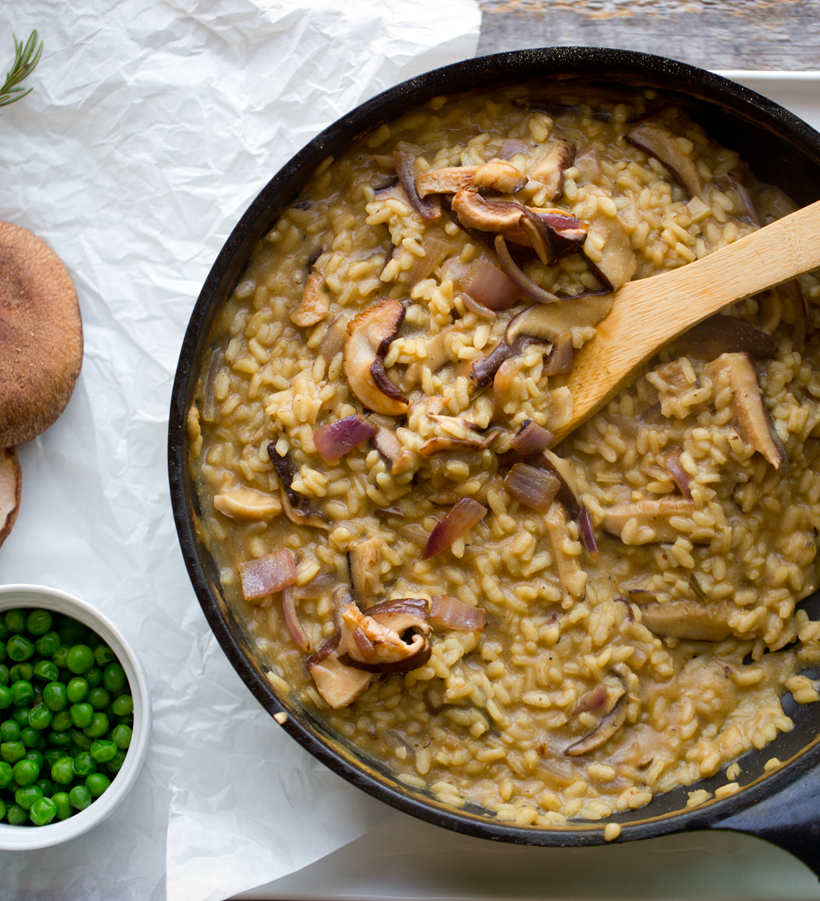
xmin=339 ymin=604 xmax=431 ymax=673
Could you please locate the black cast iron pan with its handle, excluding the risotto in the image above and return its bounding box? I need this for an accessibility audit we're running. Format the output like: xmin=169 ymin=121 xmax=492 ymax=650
xmin=168 ymin=47 xmax=820 ymax=876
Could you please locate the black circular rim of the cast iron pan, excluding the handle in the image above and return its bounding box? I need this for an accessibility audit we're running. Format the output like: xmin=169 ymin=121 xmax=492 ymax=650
xmin=168 ymin=47 xmax=820 ymax=847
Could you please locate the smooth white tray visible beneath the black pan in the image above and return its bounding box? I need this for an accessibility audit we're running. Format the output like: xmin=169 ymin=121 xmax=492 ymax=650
xmin=236 ymin=71 xmax=820 ymax=901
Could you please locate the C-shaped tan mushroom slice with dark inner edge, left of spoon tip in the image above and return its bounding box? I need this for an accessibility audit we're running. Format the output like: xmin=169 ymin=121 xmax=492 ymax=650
xmin=344 ymin=300 xmax=408 ymax=416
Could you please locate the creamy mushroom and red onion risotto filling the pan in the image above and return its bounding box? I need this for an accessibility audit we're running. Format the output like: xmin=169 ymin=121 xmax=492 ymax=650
xmin=188 ymin=88 xmax=820 ymax=838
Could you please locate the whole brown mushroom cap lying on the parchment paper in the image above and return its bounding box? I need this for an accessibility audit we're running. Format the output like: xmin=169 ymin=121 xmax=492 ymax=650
xmin=0 ymin=222 xmax=83 ymax=448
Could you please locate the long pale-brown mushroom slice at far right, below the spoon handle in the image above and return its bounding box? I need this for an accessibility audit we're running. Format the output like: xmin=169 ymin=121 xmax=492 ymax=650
xmin=703 ymin=353 xmax=789 ymax=476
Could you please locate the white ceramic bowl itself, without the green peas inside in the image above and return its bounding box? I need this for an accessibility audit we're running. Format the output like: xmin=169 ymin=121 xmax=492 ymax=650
xmin=0 ymin=585 xmax=151 ymax=851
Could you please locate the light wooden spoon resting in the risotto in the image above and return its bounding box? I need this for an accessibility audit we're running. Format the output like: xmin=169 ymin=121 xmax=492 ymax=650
xmin=555 ymin=201 xmax=820 ymax=440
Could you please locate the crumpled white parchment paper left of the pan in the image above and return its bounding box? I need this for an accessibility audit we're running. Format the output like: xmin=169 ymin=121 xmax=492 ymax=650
xmin=0 ymin=0 xmax=480 ymax=901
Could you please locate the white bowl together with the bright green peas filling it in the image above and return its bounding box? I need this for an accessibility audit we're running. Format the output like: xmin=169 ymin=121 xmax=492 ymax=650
xmin=0 ymin=585 xmax=151 ymax=851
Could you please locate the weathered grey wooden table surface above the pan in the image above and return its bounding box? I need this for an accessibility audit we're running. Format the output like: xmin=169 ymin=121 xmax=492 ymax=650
xmin=478 ymin=0 xmax=820 ymax=70
